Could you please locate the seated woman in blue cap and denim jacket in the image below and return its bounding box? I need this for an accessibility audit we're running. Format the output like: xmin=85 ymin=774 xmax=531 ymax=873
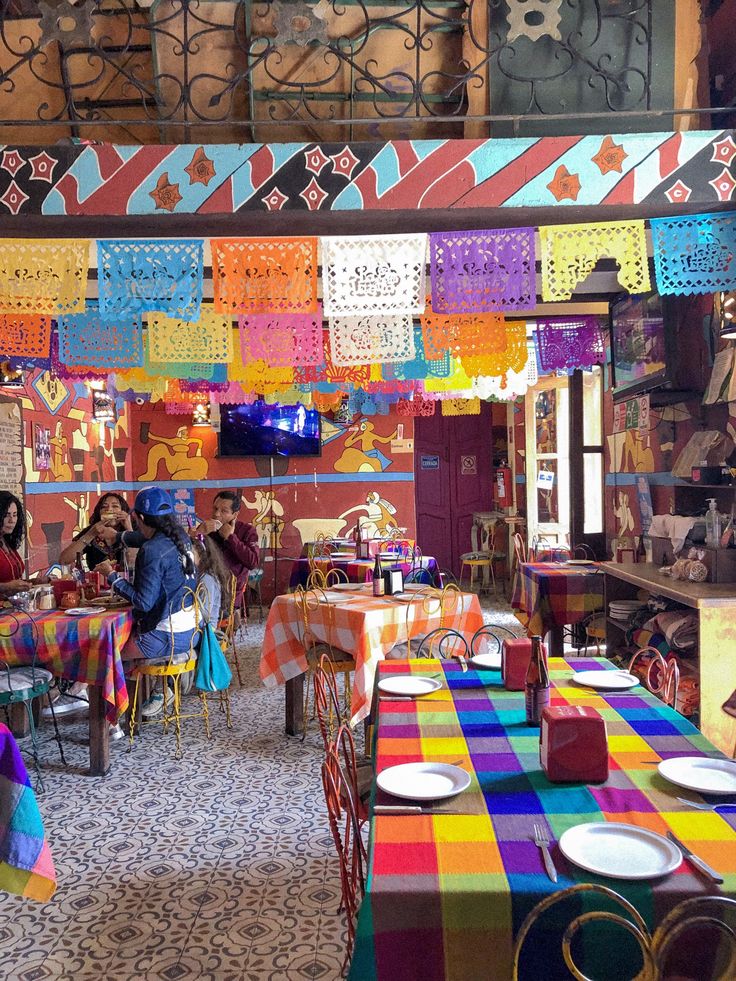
xmin=97 ymin=487 xmax=197 ymax=661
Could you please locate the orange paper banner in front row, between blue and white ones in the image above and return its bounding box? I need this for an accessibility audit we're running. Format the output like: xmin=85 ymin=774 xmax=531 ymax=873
xmin=211 ymin=238 xmax=317 ymax=314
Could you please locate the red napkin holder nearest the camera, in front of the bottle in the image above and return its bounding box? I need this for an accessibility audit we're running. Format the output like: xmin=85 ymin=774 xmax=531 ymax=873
xmin=539 ymin=705 xmax=608 ymax=783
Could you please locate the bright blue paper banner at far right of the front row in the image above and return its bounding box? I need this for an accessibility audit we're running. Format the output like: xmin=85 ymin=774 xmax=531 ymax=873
xmin=649 ymin=212 xmax=736 ymax=294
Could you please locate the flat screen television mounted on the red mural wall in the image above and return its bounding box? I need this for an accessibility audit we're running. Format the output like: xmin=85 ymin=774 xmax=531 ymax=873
xmin=219 ymin=402 xmax=322 ymax=457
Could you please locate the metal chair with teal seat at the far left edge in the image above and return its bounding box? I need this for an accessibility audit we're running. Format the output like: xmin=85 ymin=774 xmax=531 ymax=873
xmin=0 ymin=610 xmax=66 ymax=791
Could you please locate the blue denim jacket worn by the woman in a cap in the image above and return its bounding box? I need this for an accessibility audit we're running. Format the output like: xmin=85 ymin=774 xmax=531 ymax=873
xmin=109 ymin=531 xmax=197 ymax=632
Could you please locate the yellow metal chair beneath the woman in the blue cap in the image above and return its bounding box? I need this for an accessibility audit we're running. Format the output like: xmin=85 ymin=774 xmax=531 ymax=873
xmin=128 ymin=590 xmax=211 ymax=759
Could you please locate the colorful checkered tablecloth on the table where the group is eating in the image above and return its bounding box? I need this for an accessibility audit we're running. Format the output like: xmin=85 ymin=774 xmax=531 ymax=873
xmin=0 ymin=610 xmax=133 ymax=723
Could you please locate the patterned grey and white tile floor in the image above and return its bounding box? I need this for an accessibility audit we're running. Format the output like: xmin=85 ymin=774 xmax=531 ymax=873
xmin=0 ymin=597 xmax=518 ymax=981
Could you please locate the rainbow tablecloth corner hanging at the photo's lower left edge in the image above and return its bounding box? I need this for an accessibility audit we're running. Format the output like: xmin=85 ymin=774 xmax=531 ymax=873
xmin=0 ymin=722 xmax=56 ymax=902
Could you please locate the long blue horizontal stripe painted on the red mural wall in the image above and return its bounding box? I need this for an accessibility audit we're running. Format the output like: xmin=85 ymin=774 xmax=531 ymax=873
xmin=26 ymin=470 xmax=414 ymax=495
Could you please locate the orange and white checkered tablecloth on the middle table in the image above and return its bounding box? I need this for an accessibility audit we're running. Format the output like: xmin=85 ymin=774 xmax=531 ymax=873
xmin=260 ymin=589 xmax=483 ymax=725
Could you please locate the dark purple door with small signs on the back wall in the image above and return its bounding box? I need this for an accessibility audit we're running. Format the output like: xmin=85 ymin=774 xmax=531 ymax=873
xmin=414 ymin=402 xmax=493 ymax=576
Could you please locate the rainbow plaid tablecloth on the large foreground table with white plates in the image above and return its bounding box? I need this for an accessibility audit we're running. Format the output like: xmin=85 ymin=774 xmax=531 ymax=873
xmin=350 ymin=658 xmax=736 ymax=981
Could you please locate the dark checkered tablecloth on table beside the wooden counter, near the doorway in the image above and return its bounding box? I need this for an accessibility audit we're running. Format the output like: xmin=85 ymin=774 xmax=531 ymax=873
xmin=511 ymin=562 xmax=605 ymax=636
